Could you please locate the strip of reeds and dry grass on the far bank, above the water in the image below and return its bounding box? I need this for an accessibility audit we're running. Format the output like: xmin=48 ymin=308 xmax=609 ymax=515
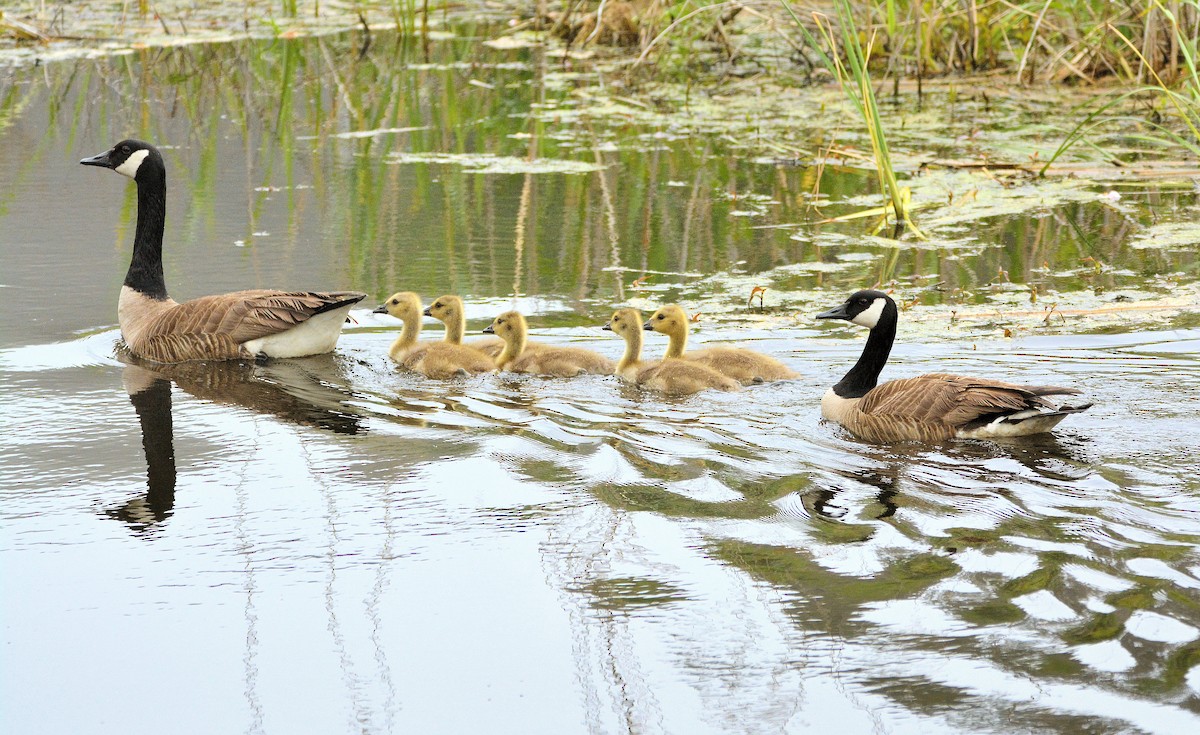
xmin=0 ymin=0 xmax=1200 ymax=88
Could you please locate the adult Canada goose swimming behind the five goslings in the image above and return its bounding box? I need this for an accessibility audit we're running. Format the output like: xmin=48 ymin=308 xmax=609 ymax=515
xmin=817 ymin=291 xmax=1091 ymax=442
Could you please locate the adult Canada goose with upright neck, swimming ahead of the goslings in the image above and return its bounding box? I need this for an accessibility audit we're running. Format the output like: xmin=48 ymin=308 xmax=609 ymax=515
xmin=79 ymin=141 xmax=367 ymax=363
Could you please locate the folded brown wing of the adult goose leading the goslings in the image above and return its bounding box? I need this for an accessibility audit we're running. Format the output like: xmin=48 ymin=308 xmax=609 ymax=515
xmin=146 ymin=291 xmax=366 ymax=345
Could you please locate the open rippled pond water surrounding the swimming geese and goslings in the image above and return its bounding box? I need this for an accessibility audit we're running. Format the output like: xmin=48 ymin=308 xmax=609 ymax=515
xmin=0 ymin=28 xmax=1200 ymax=733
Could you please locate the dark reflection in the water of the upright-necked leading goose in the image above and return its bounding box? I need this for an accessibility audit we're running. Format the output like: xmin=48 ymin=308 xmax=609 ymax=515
xmin=106 ymin=354 xmax=366 ymax=532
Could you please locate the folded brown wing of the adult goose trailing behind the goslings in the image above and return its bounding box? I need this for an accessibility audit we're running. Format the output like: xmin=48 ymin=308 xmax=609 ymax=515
xmin=858 ymin=372 xmax=1076 ymax=428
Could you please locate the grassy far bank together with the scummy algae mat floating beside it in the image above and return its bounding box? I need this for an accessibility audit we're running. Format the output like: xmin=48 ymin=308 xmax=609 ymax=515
xmin=7 ymin=0 xmax=1200 ymax=336
